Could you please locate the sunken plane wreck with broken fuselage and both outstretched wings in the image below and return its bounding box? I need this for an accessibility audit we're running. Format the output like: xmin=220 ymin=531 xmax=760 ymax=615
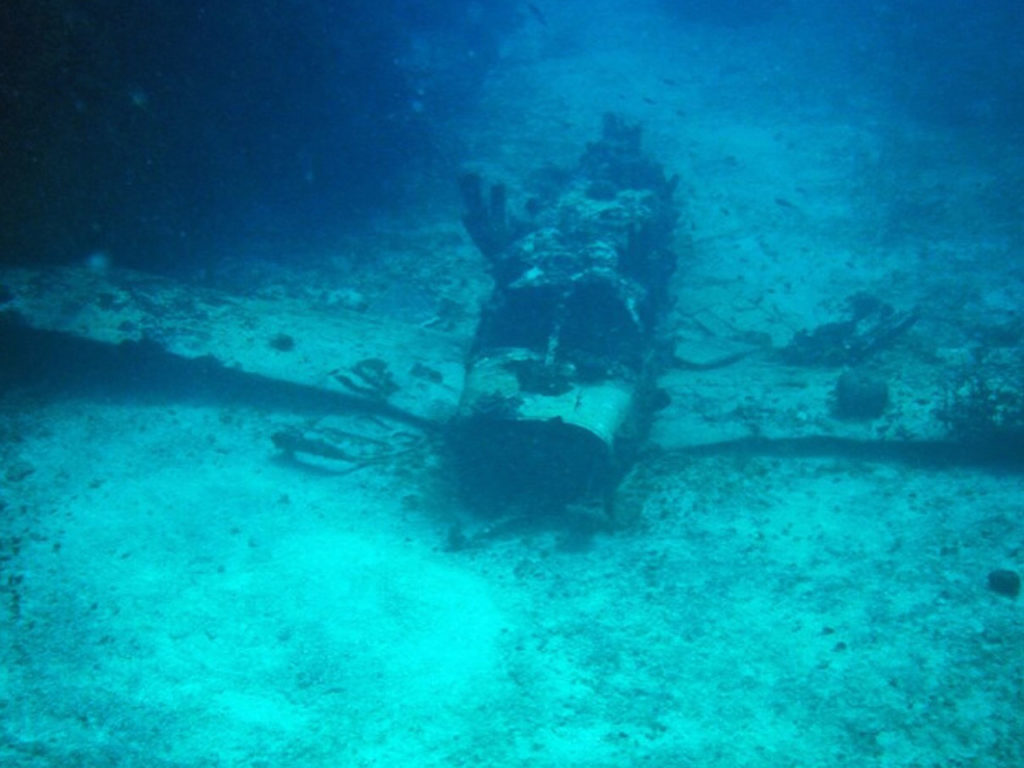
xmin=0 ymin=115 xmax=978 ymax=518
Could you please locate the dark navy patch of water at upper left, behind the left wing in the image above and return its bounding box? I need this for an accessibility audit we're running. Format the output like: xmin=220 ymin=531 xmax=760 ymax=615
xmin=0 ymin=0 xmax=518 ymax=268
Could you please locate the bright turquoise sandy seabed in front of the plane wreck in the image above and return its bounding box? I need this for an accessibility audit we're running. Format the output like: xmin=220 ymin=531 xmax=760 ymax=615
xmin=0 ymin=398 xmax=1024 ymax=766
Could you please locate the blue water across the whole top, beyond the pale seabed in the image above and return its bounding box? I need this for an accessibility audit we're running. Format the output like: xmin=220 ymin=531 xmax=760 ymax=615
xmin=0 ymin=0 xmax=1024 ymax=276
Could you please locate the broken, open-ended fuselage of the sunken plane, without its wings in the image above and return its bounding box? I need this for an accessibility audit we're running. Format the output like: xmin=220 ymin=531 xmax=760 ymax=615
xmin=453 ymin=115 xmax=679 ymax=514
